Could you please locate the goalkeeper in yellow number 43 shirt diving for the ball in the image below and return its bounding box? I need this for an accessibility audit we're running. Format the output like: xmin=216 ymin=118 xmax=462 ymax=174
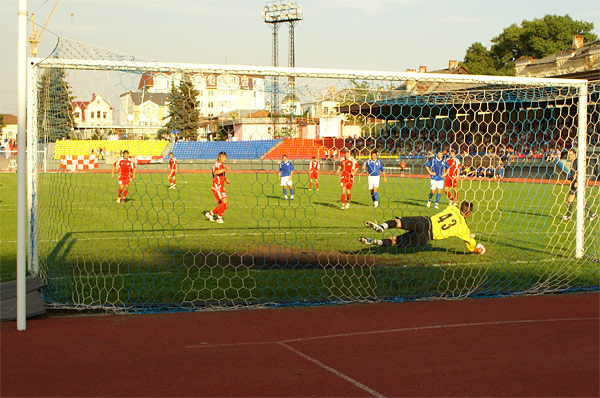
xmin=358 ymin=200 xmax=485 ymax=254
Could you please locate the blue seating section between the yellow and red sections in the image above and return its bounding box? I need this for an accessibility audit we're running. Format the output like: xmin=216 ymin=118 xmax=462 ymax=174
xmin=172 ymin=140 xmax=281 ymax=160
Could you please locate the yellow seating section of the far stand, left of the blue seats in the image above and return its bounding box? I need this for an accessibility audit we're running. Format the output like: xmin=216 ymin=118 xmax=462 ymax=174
xmin=54 ymin=140 xmax=168 ymax=159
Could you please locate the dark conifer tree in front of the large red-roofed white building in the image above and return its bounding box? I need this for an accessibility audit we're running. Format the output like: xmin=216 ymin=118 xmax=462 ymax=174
xmin=161 ymin=75 xmax=200 ymax=140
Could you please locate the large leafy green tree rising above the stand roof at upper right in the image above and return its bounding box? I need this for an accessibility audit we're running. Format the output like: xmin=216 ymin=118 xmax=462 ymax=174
xmin=462 ymin=15 xmax=598 ymax=76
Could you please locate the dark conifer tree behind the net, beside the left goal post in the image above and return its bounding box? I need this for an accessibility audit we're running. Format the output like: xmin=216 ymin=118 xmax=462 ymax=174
xmin=37 ymin=68 xmax=74 ymax=142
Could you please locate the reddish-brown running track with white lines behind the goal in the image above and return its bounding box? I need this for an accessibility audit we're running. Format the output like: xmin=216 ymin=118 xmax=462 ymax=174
xmin=0 ymin=293 xmax=600 ymax=397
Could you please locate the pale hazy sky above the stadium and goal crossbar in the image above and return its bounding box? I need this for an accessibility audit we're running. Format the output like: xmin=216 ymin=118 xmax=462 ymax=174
xmin=0 ymin=0 xmax=600 ymax=114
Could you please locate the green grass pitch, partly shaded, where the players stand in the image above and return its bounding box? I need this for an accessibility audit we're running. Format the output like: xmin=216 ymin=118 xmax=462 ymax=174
xmin=0 ymin=172 xmax=600 ymax=307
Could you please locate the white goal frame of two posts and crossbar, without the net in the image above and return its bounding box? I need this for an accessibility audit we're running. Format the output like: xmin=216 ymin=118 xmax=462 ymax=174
xmin=17 ymin=58 xmax=588 ymax=330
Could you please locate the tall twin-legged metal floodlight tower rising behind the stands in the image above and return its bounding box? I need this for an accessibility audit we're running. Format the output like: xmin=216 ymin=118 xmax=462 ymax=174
xmin=263 ymin=0 xmax=302 ymax=120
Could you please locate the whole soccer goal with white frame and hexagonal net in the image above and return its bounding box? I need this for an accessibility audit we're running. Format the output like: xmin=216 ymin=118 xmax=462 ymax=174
xmin=28 ymin=42 xmax=600 ymax=312
